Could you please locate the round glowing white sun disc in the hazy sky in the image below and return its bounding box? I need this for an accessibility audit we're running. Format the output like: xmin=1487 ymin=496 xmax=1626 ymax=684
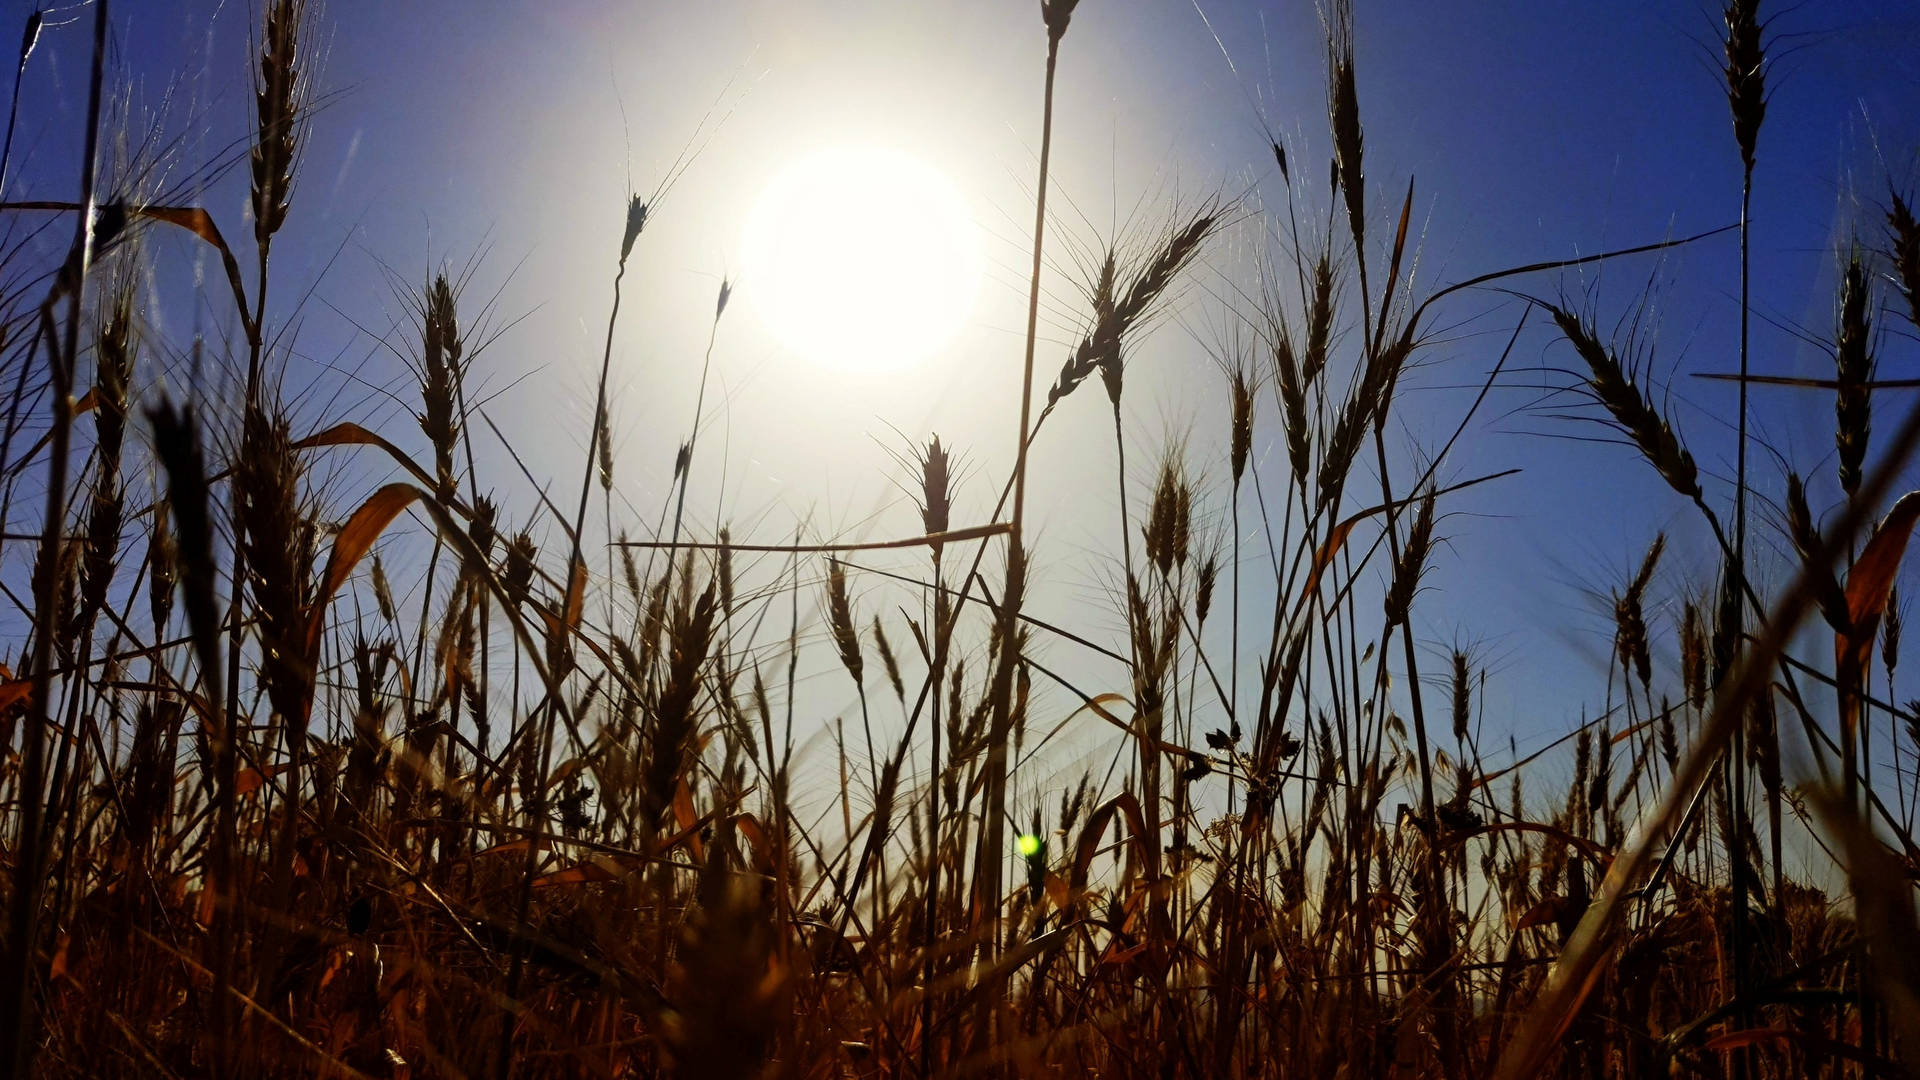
xmin=741 ymin=150 xmax=981 ymax=371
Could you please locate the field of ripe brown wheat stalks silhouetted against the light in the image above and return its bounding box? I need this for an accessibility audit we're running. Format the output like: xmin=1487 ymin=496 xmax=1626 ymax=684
xmin=0 ymin=0 xmax=1920 ymax=1078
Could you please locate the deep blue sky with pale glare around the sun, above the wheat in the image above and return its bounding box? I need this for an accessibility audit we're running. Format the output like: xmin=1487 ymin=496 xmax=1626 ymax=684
xmin=0 ymin=0 xmax=1920 ymax=826
